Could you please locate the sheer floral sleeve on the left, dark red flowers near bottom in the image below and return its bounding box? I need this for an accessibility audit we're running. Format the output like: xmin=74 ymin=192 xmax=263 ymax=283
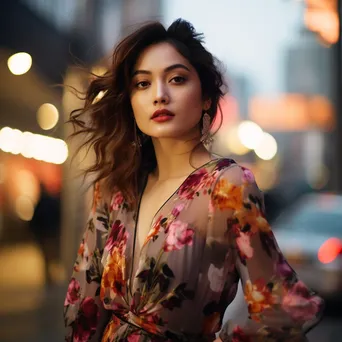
xmin=64 ymin=184 xmax=109 ymax=342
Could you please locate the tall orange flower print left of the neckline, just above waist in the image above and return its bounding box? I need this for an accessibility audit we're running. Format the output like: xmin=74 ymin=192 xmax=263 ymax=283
xmin=101 ymin=247 xmax=126 ymax=300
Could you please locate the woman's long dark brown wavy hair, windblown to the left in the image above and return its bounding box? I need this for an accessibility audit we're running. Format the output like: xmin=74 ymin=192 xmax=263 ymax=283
xmin=68 ymin=19 xmax=225 ymax=208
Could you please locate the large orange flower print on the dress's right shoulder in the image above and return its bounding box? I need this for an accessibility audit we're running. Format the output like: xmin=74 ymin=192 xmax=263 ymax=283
xmin=212 ymin=179 xmax=242 ymax=210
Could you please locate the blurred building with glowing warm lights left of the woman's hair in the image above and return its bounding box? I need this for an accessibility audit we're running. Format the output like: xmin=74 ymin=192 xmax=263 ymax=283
xmin=0 ymin=0 xmax=160 ymax=288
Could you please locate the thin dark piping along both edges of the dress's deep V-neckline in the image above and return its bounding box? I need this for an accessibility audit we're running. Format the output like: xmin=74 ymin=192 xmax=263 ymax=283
xmin=129 ymin=158 xmax=222 ymax=296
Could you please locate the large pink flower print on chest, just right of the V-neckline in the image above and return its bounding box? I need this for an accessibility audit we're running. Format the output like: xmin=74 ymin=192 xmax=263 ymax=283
xmin=164 ymin=220 xmax=194 ymax=252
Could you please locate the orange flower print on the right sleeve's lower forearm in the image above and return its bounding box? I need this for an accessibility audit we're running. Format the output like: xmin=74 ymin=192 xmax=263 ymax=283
xmin=245 ymin=279 xmax=274 ymax=319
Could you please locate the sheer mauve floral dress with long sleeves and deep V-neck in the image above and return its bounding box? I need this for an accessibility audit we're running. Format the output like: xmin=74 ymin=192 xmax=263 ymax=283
xmin=64 ymin=159 xmax=323 ymax=342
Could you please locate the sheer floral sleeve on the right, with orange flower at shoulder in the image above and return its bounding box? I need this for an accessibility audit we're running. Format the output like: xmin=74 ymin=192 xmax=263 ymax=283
xmin=212 ymin=166 xmax=323 ymax=342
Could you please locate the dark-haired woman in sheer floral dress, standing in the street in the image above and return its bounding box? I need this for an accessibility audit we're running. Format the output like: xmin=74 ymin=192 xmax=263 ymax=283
xmin=64 ymin=20 xmax=323 ymax=342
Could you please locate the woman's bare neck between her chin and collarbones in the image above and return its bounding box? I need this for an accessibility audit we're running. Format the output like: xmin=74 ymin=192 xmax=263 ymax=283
xmin=152 ymin=139 xmax=212 ymax=181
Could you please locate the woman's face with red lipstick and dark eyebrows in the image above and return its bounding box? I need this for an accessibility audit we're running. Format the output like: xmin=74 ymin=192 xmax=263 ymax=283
xmin=131 ymin=43 xmax=210 ymax=139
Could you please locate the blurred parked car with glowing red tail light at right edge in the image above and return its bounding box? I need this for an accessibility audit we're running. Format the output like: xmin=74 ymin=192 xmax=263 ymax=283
xmin=273 ymin=193 xmax=342 ymax=299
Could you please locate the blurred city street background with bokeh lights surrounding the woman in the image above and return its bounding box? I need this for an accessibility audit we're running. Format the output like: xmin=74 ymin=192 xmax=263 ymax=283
xmin=0 ymin=0 xmax=342 ymax=342
